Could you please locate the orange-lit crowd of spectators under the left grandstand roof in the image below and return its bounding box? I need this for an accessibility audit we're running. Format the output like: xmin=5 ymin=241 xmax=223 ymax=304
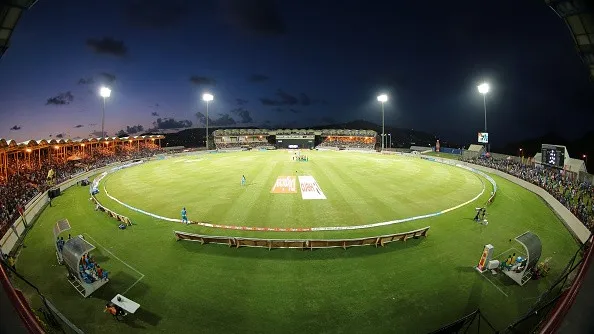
xmin=0 ymin=144 xmax=160 ymax=236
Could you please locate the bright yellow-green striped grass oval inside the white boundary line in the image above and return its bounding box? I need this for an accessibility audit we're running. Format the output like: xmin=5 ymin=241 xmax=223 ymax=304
xmin=101 ymin=151 xmax=483 ymax=231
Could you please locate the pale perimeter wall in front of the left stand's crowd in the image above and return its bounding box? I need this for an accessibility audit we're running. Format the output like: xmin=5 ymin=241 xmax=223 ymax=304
xmin=0 ymin=164 xmax=118 ymax=254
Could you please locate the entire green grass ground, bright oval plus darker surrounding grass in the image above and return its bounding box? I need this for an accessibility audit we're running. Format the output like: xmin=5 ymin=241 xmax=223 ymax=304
xmin=12 ymin=151 xmax=578 ymax=333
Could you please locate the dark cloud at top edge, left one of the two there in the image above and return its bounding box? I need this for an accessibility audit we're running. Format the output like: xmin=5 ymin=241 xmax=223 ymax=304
xmin=123 ymin=0 xmax=189 ymax=29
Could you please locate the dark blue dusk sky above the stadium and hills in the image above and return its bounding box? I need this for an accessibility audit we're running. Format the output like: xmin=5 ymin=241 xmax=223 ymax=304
xmin=0 ymin=0 xmax=594 ymax=145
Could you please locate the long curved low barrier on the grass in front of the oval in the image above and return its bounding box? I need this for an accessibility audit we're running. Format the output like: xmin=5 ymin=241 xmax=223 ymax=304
xmin=173 ymin=226 xmax=430 ymax=250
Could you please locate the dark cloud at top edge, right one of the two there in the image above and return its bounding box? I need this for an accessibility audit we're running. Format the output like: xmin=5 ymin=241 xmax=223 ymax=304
xmin=221 ymin=0 xmax=287 ymax=36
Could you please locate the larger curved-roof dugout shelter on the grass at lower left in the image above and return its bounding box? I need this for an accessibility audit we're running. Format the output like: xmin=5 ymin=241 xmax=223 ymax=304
xmin=62 ymin=235 xmax=109 ymax=298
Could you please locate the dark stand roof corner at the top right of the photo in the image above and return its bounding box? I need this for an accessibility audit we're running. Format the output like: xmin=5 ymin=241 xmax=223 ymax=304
xmin=545 ymin=0 xmax=594 ymax=79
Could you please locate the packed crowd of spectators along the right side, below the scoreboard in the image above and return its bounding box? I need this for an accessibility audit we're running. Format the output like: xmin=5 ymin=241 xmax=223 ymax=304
xmin=467 ymin=158 xmax=594 ymax=230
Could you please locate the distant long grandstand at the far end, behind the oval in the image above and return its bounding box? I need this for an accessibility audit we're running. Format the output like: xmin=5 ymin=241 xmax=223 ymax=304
xmin=213 ymin=129 xmax=377 ymax=150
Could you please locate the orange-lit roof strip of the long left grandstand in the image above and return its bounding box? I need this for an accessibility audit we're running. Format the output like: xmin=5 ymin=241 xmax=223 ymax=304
xmin=0 ymin=135 xmax=165 ymax=151
